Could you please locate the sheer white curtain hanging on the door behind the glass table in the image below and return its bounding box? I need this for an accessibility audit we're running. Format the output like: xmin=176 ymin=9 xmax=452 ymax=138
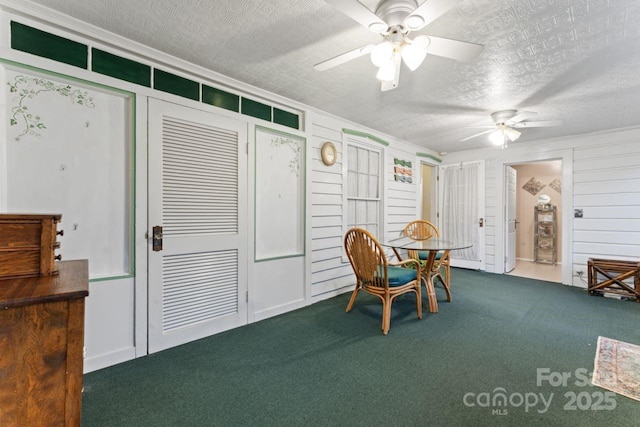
xmin=440 ymin=163 xmax=480 ymax=261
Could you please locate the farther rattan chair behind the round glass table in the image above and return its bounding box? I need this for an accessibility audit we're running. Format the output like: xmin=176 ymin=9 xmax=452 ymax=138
xmin=402 ymin=219 xmax=451 ymax=302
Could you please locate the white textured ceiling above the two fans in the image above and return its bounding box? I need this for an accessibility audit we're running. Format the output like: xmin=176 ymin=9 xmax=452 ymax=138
xmin=23 ymin=0 xmax=640 ymax=152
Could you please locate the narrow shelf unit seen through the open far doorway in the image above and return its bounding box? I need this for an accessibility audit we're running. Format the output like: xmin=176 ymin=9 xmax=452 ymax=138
xmin=533 ymin=204 xmax=558 ymax=265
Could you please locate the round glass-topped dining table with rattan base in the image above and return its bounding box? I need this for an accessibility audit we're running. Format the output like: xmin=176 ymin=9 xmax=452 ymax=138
xmin=380 ymin=236 xmax=473 ymax=313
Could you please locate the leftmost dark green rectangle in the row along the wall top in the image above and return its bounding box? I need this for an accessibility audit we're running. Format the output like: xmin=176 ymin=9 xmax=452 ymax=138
xmin=11 ymin=21 xmax=89 ymax=69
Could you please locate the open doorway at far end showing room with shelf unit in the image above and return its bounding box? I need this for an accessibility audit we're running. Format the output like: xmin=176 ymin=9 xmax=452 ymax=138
xmin=504 ymin=160 xmax=563 ymax=283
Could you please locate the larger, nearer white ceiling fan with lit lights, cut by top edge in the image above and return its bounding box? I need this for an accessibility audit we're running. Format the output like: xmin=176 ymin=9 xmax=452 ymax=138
xmin=314 ymin=0 xmax=484 ymax=91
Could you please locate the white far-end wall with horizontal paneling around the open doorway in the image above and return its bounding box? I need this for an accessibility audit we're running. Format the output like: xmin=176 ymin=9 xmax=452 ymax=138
xmin=445 ymin=125 xmax=640 ymax=287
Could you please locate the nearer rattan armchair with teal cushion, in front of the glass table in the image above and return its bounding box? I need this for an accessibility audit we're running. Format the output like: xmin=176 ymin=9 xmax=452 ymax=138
xmin=344 ymin=228 xmax=422 ymax=335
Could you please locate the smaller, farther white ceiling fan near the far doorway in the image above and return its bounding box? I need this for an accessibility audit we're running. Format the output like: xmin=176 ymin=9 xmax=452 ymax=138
xmin=460 ymin=110 xmax=562 ymax=148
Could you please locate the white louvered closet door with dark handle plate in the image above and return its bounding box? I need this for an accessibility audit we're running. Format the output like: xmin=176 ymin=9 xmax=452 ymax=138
xmin=149 ymin=99 xmax=247 ymax=353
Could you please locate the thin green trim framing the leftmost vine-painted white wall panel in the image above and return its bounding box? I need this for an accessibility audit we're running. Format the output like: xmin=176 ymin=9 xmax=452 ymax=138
xmin=0 ymin=58 xmax=137 ymax=282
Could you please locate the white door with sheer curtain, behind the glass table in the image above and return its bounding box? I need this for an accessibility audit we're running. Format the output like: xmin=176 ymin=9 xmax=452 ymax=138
xmin=438 ymin=161 xmax=485 ymax=270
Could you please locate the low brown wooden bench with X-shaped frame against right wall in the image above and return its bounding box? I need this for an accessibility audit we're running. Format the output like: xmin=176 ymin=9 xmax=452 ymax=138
xmin=587 ymin=258 xmax=640 ymax=302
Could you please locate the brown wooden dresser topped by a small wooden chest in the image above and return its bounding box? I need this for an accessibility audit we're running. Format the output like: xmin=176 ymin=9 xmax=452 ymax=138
xmin=0 ymin=260 xmax=89 ymax=427
